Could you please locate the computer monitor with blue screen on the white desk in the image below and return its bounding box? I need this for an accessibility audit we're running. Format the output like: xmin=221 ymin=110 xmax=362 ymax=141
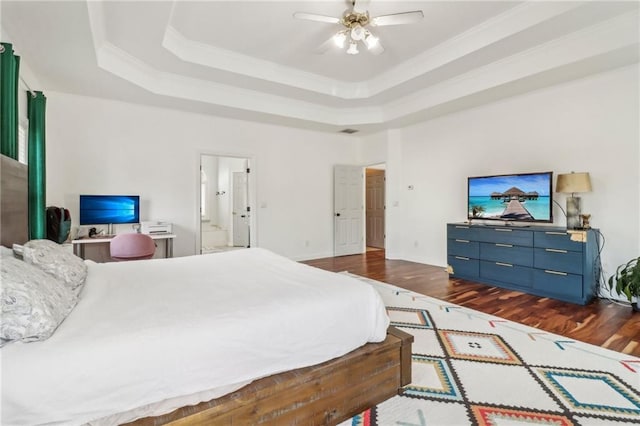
xmin=80 ymin=195 xmax=140 ymax=225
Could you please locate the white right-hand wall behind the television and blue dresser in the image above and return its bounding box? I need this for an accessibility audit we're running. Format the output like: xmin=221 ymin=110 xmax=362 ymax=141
xmin=360 ymin=65 xmax=640 ymax=300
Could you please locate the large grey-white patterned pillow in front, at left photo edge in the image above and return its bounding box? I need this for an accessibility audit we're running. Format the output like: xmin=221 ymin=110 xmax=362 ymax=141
xmin=0 ymin=257 xmax=78 ymax=346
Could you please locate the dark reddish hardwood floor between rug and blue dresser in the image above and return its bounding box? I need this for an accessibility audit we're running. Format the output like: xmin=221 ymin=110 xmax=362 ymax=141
xmin=304 ymin=250 xmax=640 ymax=356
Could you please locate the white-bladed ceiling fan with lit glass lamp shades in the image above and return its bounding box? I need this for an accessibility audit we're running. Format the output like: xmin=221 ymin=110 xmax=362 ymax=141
xmin=293 ymin=0 xmax=424 ymax=55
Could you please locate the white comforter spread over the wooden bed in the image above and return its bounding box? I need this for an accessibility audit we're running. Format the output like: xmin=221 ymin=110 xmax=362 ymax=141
xmin=1 ymin=249 xmax=389 ymax=426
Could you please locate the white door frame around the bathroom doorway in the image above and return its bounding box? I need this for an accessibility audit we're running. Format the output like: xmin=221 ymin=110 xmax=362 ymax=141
xmin=194 ymin=150 xmax=258 ymax=254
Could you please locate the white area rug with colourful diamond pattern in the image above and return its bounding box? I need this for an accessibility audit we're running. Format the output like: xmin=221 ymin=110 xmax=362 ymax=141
xmin=340 ymin=274 xmax=640 ymax=426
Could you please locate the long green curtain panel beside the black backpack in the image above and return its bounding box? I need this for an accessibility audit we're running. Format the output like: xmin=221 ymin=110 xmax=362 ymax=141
xmin=27 ymin=92 xmax=47 ymax=240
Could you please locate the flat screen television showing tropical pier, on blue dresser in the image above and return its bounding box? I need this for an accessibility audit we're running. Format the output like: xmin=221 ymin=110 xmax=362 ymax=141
xmin=467 ymin=172 xmax=553 ymax=222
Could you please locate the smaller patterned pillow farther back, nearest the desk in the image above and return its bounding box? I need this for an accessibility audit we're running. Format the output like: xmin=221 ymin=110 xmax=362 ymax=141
xmin=22 ymin=240 xmax=87 ymax=295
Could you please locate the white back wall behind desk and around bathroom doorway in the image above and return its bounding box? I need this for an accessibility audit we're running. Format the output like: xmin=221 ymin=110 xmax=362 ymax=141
xmin=46 ymin=92 xmax=357 ymax=259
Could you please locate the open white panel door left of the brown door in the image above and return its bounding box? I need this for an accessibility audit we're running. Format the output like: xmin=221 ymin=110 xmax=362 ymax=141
xmin=333 ymin=166 xmax=364 ymax=256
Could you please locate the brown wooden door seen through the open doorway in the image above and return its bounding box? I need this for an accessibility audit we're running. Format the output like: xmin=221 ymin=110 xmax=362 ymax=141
xmin=365 ymin=164 xmax=386 ymax=251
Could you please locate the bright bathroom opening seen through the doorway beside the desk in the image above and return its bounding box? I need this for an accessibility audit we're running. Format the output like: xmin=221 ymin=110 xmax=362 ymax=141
xmin=199 ymin=154 xmax=251 ymax=254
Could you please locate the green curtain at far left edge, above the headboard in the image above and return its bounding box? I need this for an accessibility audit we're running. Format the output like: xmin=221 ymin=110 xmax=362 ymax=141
xmin=0 ymin=43 xmax=20 ymax=159
